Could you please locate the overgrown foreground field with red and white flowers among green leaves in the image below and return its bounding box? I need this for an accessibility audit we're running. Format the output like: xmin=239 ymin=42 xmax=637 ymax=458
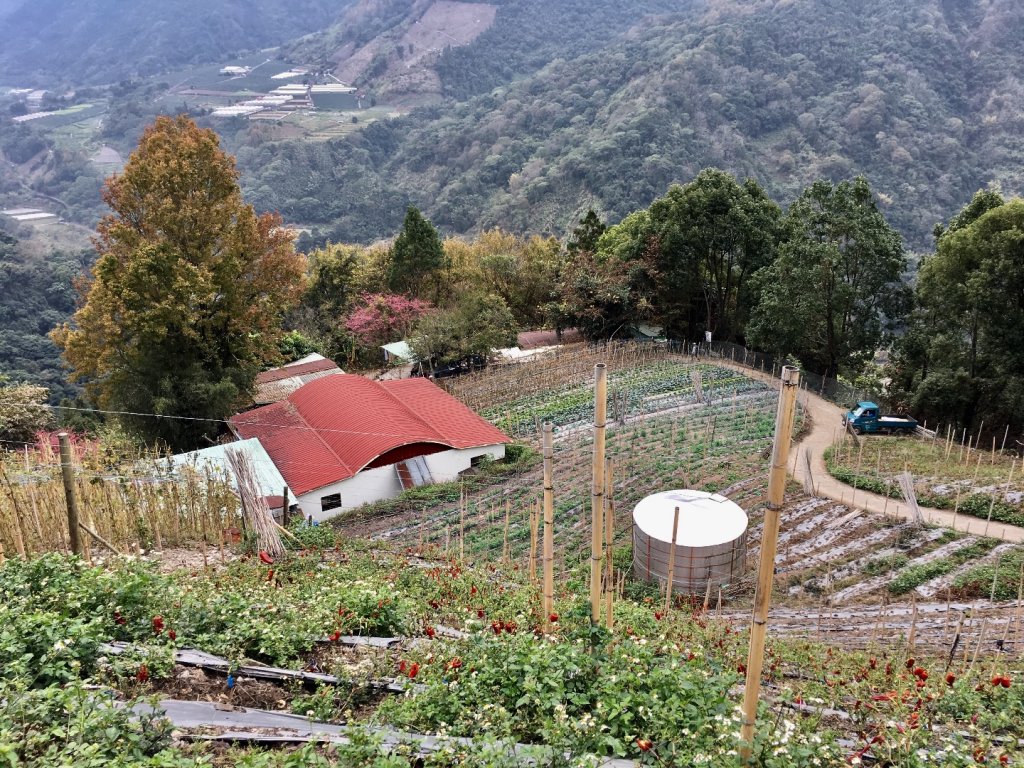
xmin=0 ymin=541 xmax=1024 ymax=767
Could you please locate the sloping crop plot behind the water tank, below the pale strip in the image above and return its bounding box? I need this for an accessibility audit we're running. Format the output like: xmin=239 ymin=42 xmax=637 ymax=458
xmin=339 ymin=387 xmax=776 ymax=577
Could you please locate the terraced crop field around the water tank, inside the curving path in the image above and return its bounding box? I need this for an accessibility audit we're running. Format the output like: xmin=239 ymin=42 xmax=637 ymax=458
xmin=341 ymin=355 xmax=1024 ymax=653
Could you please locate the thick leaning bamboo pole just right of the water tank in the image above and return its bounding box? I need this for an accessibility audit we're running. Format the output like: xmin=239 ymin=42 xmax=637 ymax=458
xmin=739 ymin=366 xmax=800 ymax=763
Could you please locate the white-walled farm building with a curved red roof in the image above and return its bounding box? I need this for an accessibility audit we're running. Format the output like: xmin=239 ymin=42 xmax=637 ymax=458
xmin=229 ymin=374 xmax=509 ymax=520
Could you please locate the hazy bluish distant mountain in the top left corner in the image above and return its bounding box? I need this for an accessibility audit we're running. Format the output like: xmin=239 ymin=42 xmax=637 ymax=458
xmin=0 ymin=0 xmax=349 ymax=87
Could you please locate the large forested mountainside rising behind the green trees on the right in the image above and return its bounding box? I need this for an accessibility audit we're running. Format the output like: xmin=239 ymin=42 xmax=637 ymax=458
xmin=240 ymin=0 xmax=1024 ymax=249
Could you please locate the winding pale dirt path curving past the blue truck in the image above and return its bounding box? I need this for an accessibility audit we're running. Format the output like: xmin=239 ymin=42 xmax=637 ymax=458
xmin=713 ymin=360 xmax=1024 ymax=542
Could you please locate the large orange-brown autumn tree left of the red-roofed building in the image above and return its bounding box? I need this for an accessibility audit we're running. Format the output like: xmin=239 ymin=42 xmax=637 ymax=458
xmin=53 ymin=116 xmax=305 ymax=449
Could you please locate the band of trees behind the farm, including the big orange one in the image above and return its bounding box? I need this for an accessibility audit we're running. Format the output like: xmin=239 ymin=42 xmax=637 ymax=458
xmin=5 ymin=110 xmax=1024 ymax=449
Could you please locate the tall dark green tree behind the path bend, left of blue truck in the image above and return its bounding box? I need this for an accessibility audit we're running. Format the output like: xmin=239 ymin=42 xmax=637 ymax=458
xmin=748 ymin=177 xmax=909 ymax=376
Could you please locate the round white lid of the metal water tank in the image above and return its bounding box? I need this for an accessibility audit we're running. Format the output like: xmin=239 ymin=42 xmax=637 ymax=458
xmin=633 ymin=490 xmax=748 ymax=547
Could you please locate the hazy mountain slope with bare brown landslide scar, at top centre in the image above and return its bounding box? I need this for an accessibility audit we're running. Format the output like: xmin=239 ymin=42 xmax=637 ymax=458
xmin=285 ymin=0 xmax=688 ymax=103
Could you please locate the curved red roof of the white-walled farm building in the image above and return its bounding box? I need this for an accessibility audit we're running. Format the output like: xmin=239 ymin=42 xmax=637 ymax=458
xmin=230 ymin=374 xmax=509 ymax=496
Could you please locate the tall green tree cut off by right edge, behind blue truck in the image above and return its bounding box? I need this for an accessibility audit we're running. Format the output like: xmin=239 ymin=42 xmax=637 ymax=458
xmin=890 ymin=190 xmax=1024 ymax=432
